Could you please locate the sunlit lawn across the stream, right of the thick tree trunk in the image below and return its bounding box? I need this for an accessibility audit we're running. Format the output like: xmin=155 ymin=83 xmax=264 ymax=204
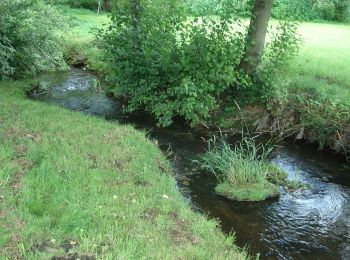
xmin=290 ymin=23 xmax=350 ymax=102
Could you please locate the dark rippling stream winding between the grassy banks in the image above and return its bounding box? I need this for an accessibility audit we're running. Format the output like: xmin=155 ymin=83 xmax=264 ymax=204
xmin=34 ymin=69 xmax=350 ymax=259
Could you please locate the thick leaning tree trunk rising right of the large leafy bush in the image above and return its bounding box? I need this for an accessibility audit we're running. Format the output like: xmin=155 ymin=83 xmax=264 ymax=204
xmin=240 ymin=0 xmax=273 ymax=75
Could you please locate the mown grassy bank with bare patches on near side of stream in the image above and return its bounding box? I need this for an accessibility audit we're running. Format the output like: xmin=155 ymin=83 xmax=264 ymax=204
xmin=0 ymin=81 xmax=246 ymax=259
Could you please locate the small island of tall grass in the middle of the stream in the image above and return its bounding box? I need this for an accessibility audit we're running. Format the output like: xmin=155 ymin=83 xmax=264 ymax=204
xmin=202 ymin=138 xmax=301 ymax=201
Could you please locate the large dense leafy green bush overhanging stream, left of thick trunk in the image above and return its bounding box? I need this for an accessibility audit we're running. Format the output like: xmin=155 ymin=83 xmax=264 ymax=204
xmin=102 ymin=0 xmax=244 ymax=126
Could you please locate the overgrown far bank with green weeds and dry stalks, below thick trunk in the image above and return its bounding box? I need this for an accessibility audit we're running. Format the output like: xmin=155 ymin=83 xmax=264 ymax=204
xmin=213 ymin=97 xmax=350 ymax=159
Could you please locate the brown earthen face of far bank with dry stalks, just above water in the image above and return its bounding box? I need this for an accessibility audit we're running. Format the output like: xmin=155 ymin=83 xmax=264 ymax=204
xmin=226 ymin=103 xmax=350 ymax=155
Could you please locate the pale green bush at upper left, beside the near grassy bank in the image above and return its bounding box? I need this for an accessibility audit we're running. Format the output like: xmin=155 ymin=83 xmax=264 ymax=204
xmin=0 ymin=0 xmax=65 ymax=78
